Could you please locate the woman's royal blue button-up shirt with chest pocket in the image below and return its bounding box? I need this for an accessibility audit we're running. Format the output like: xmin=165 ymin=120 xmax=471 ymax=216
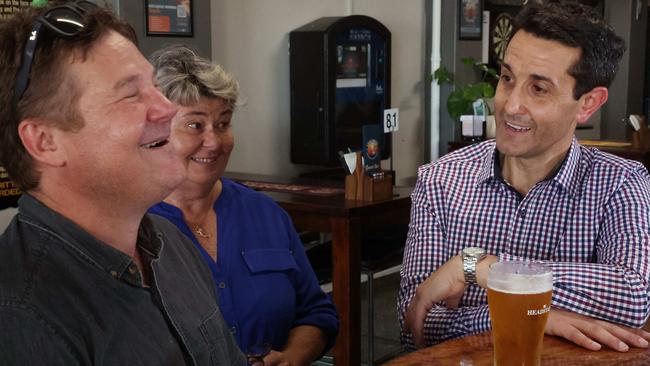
xmin=150 ymin=178 xmax=338 ymax=351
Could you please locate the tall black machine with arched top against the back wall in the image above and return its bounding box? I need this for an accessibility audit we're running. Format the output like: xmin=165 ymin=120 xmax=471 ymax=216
xmin=289 ymin=15 xmax=391 ymax=166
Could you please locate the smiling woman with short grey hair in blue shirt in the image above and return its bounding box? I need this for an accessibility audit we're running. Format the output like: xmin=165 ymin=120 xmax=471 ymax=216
xmin=150 ymin=46 xmax=338 ymax=366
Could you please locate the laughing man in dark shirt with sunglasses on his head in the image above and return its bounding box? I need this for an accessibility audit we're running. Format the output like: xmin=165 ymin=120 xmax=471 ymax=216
xmin=0 ymin=1 xmax=246 ymax=365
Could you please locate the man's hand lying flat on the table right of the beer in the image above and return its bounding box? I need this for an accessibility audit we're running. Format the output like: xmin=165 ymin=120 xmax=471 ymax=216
xmin=545 ymin=309 xmax=650 ymax=352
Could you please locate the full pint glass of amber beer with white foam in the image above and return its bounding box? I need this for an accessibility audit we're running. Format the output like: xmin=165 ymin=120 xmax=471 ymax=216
xmin=487 ymin=262 xmax=553 ymax=366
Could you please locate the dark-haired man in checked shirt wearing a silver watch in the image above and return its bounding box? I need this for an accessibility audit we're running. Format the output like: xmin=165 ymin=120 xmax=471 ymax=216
xmin=398 ymin=2 xmax=650 ymax=352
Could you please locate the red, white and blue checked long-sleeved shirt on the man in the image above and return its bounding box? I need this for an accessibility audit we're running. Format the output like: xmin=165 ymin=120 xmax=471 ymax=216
xmin=398 ymin=139 xmax=650 ymax=346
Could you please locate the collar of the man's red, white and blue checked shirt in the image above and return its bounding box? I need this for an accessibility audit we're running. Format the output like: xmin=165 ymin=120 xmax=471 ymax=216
xmin=477 ymin=137 xmax=581 ymax=195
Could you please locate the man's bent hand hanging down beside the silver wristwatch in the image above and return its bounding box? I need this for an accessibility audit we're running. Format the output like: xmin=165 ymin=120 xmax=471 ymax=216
xmin=404 ymin=255 xmax=465 ymax=347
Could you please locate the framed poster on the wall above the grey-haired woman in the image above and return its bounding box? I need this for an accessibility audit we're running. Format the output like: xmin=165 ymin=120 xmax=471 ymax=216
xmin=145 ymin=0 xmax=193 ymax=37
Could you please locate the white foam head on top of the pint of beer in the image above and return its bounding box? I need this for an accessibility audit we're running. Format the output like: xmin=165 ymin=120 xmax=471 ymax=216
xmin=488 ymin=262 xmax=553 ymax=294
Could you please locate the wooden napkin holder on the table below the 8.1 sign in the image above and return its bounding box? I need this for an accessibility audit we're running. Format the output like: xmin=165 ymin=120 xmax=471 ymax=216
xmin=345 ymin=152 xmax=393 ymax=202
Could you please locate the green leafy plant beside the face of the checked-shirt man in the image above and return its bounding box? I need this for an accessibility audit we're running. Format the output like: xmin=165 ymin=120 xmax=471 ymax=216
xmin=432 ymin=57 xmax=499 ymax=121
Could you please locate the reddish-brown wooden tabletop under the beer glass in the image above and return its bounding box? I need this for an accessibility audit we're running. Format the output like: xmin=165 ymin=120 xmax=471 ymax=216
xmin=384 ymin=332 xmax=650 ymax=366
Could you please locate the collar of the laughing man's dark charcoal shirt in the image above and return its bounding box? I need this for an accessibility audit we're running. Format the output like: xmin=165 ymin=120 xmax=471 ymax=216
xmin=19 ymin=193 xmax=162 ymax=282
